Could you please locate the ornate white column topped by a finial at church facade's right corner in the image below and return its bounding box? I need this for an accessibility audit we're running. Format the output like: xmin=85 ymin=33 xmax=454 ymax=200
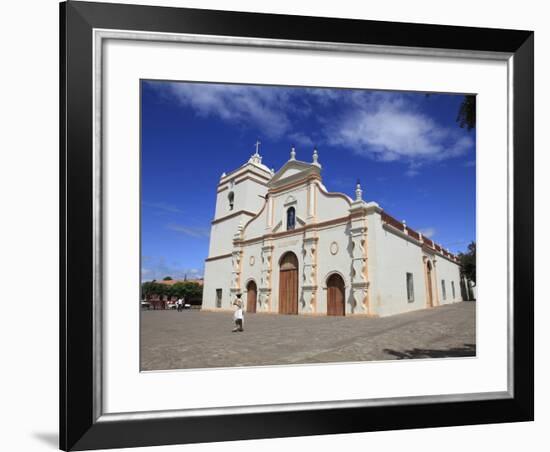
xmin=349 ymin=181 xmax=369 ymax=314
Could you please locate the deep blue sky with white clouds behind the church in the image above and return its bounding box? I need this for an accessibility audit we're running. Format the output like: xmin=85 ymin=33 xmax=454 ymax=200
xmin=141 ymin=81 xmax=476 ymax=280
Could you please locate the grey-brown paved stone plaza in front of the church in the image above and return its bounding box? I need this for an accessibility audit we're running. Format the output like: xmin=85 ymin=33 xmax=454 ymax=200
xmin=141 ymin=302 xmax=476 ymax=370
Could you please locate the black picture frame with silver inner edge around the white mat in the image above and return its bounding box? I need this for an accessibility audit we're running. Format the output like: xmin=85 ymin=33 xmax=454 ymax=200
xmin=60 ymin=1 xmax=534 ymax=450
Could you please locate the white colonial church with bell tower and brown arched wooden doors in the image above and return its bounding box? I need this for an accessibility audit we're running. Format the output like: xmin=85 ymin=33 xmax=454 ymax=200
xmin=202 ymin=143 xmax=462 ymax=317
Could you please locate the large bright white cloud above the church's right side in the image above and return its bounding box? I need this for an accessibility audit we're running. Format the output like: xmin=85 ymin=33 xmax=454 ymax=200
xmin=328 ymin=92 xmax=474 ymax=166
